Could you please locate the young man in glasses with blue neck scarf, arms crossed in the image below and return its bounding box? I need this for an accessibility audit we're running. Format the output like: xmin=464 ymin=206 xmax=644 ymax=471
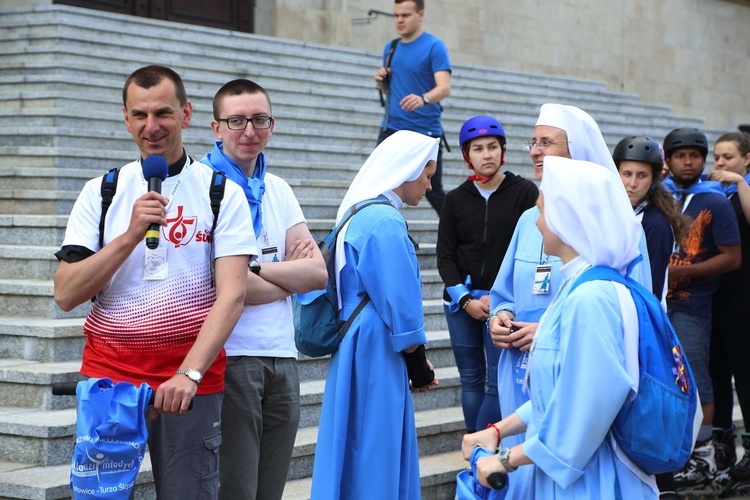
xmin=201 ymin=79 xmax=328 ymax=500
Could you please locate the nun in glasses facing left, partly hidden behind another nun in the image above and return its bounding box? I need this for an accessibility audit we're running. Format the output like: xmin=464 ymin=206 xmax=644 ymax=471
xmin=489 ymin=103 xmax=651 ymax=498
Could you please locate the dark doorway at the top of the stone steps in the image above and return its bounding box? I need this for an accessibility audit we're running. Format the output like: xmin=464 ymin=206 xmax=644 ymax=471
xmin=54 ymin=0 xmax=255 ymax=33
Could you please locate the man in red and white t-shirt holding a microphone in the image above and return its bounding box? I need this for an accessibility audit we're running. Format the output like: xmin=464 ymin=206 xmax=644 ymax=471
xmin=54 ymin=66 xmax=258 ymax=500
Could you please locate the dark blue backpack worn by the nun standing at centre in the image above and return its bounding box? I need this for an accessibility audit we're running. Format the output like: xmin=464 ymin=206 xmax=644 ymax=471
xmin=292 ymin=200 xmax=391 ymax=358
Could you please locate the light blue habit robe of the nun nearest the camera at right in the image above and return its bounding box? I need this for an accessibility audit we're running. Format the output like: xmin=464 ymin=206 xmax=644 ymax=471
xmin=511 ymin=258 xmax=657 ymax=500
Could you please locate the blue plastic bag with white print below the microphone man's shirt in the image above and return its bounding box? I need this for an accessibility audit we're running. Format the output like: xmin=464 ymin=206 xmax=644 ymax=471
xmin=70 ymin=378 xmax=153 ymax=499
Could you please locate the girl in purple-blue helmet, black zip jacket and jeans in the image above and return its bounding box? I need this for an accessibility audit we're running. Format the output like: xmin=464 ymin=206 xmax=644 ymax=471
xmin=437 ymin=115 xmax=538 ymax=432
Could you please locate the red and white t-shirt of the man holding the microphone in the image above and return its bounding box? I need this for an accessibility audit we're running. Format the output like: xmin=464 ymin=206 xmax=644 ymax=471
xmin=63 ymin=158 xmax=258 ymax=394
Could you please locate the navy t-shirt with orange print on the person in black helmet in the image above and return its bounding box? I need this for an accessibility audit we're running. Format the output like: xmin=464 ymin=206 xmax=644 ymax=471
xmin=667 ymin=193 xmax=740 ymax=317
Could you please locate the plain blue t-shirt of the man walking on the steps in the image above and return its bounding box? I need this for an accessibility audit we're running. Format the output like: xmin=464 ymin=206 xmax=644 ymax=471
xmin=381 ymin=31 xmax=451 ymax=136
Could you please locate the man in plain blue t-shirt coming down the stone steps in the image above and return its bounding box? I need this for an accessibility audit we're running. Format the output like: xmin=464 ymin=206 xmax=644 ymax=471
xmin=375 ymin=0 xmax=451 ymax=215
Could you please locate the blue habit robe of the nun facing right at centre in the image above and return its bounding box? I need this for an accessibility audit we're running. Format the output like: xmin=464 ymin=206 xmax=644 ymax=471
xmin=311 ymin=201 xmax=427 ymax=500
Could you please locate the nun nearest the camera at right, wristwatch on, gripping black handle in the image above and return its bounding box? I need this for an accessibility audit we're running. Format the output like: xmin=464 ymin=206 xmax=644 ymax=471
xmin=462 ymin=156 xmax=658 ymax=500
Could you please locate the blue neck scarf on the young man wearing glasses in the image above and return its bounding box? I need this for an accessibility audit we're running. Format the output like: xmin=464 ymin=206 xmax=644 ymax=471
xmin=201 ymin=141 xmax=266 ymax=238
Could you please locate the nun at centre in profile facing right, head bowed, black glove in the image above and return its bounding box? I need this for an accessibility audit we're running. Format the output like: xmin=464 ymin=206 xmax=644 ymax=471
xmin=311 ymin=131 xmax=439 ymax=500
